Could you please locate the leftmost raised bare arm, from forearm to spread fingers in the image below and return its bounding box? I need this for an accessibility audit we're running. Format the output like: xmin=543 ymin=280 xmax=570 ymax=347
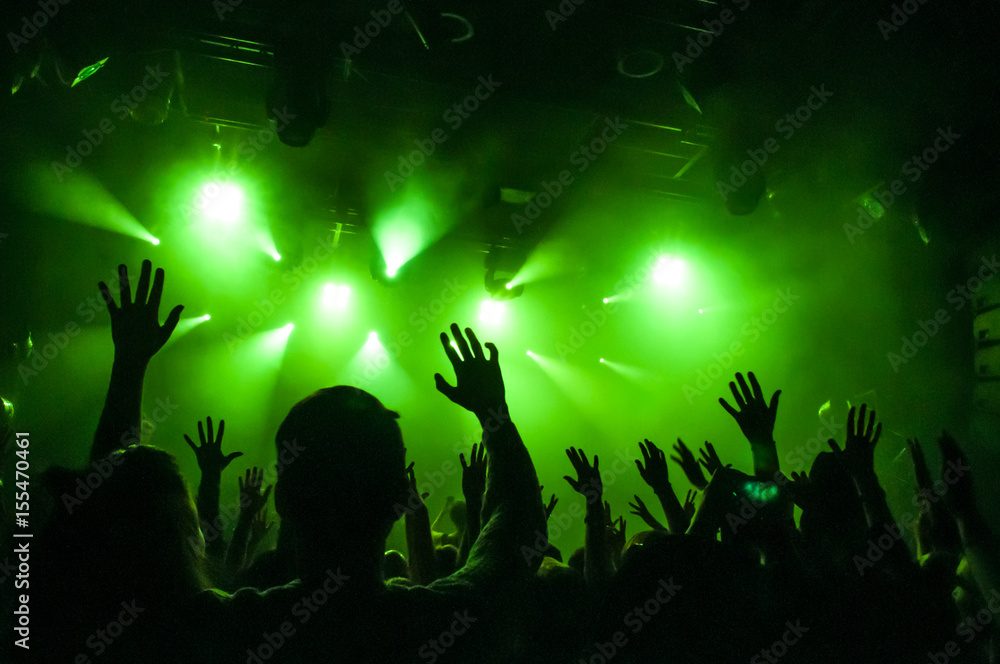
xmin=90 ymin=260 xmax=184 ymax=461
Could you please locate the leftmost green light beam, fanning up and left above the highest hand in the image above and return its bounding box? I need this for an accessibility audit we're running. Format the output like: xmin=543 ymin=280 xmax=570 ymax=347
xmin=19 ymin=165 xmax=159 ymax=244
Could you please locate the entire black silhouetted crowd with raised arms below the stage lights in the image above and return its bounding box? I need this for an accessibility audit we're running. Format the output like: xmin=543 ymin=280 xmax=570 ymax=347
xmin=7 ymin=261 xmax=1000 ymax=664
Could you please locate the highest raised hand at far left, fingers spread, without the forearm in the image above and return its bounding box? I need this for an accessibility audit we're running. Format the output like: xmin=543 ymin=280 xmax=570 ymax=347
xmin=98 ymin=260 xmax=184 ymax=367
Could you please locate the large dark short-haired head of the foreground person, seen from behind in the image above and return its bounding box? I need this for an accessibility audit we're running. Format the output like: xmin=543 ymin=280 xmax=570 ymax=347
xmin=274 ymin=385 xmax=409 ymax=541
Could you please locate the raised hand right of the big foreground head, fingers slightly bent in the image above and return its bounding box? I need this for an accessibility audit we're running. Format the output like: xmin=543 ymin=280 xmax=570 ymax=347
xmin=434 ymin=323 xmax=506 ymax=420
